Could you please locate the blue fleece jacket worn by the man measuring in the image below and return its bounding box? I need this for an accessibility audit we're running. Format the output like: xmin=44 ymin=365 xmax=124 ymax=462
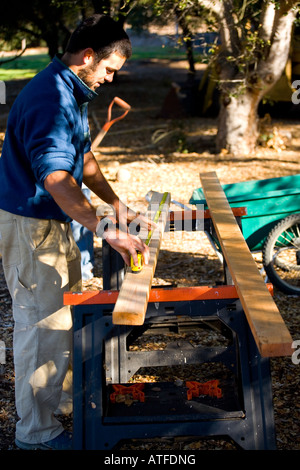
xmin=0 ymin=57 xmax=98 ymax=222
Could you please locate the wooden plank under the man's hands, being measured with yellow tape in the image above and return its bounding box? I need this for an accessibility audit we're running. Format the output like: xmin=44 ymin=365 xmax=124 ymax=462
xmin=112 ymin=192 xmax=171 ymax=325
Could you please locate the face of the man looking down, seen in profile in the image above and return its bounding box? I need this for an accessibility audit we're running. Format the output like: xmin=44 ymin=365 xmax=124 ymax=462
xmin=78 ymin=52 xmax=126 ymax=91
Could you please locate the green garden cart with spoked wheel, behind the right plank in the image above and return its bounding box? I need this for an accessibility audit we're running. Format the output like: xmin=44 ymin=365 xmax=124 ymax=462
xmin=189 ymin=174 xmax=300 ymax=295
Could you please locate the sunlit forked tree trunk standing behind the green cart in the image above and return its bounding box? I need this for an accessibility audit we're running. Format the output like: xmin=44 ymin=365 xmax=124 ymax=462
xmin=198 ymin=0 xmax=298 ymax=156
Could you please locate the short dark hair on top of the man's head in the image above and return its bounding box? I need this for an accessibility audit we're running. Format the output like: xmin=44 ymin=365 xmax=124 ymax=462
xmin=65 ymin=14 xmax=132 ymax=61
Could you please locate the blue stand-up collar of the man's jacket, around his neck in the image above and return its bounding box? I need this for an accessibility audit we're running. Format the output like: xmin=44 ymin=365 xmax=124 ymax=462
xmin=52 ymin=55 xmax=98 ymax=106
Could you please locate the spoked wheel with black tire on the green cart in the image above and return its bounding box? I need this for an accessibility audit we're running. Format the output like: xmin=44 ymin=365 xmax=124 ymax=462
xmin=263 ymin=214 xmax=300 ymax=295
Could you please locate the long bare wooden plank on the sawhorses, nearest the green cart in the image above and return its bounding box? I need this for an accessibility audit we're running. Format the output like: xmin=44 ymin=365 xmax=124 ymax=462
xmin=200 ymin=172 xmax=292 ymax=357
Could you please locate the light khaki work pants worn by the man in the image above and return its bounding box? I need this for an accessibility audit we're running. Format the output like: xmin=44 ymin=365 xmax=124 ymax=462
xmin=0 ymin=210 xmax=81 ymax=443
